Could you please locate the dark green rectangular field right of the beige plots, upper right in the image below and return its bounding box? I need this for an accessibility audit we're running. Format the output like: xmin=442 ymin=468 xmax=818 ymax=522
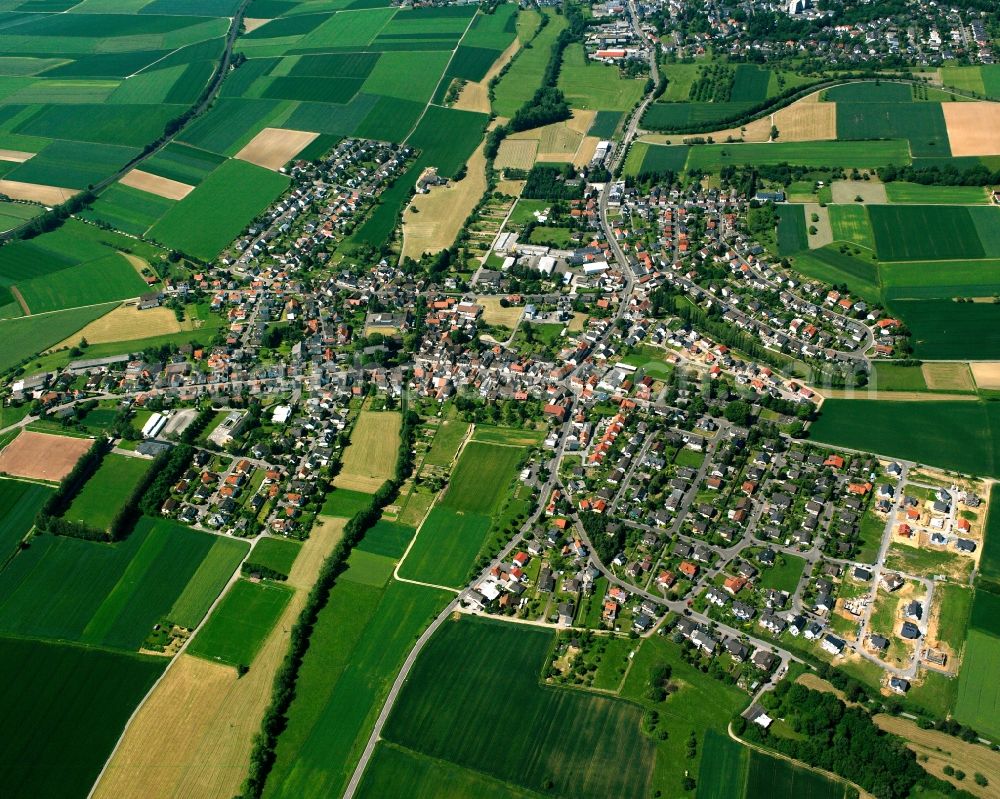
xmin=868 ymin=205 xmax=985 ymax=261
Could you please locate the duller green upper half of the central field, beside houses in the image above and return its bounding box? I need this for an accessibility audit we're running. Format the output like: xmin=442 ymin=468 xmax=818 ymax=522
xmin=441 ymin=440 xmax=525 ymax=515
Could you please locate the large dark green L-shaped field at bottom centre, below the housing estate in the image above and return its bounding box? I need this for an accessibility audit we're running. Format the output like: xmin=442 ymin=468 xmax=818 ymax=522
xmin=383 ymin=618 xmax=655 ymax=799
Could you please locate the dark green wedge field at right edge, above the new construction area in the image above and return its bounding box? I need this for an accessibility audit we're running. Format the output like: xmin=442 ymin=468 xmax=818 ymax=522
xmin=810 ymin=399 xmax=1000 ymax=477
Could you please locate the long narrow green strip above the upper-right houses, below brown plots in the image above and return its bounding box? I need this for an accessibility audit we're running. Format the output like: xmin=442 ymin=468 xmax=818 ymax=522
xmin=687 ymin=139 xmax=910 ymax=172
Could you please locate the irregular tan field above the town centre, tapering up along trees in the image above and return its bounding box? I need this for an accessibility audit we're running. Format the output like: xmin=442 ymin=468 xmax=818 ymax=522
xmin=403 ymin=144 xmax=486 ymax=259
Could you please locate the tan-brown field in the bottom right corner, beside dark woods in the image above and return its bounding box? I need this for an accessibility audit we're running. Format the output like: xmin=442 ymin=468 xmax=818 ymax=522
xmin=873 ymin=713 xmax=1000 ymax=797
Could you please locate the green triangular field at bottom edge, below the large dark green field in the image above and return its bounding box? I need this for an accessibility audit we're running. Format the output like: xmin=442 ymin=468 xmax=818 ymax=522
xmin=357 ymin=741 xmax=543 ymax=799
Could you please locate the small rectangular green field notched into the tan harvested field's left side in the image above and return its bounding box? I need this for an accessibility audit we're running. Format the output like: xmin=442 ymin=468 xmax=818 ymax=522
xmin=187 ymin=579 xmax=293 ymax=666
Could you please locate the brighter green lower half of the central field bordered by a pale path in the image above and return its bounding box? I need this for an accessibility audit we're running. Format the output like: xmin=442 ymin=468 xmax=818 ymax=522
xmin=399 ymin=505 xmax=492 ymax=587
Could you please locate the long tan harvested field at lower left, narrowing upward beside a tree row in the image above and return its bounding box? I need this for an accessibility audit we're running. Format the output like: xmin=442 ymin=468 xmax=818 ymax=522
xmin=94 ymin=516 xmax=346 ymax=799
